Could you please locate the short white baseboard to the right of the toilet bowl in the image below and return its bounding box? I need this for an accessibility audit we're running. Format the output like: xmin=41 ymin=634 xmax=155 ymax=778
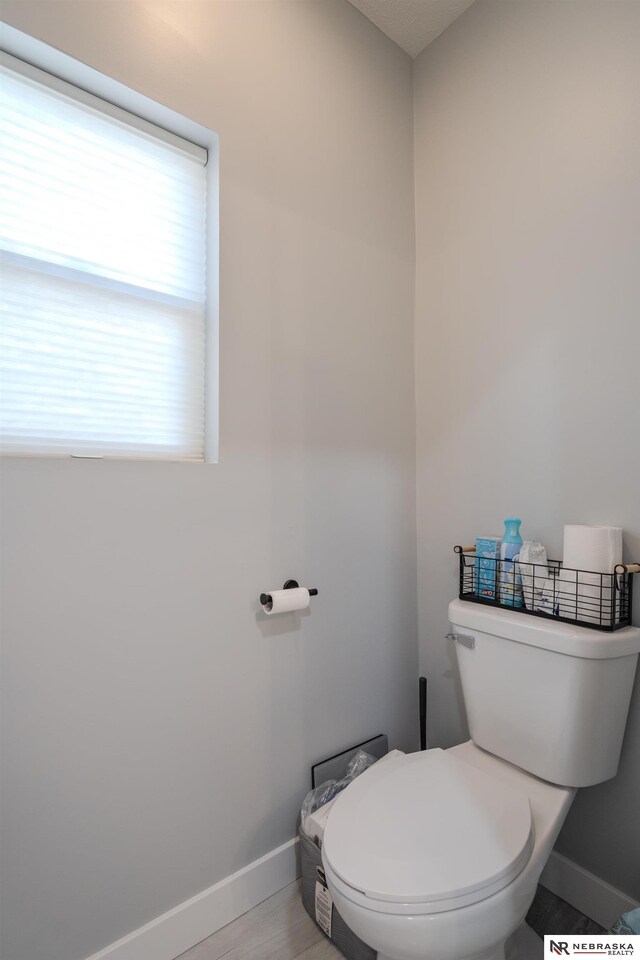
xmin=540 ymin=850 xmax=640 ymax=930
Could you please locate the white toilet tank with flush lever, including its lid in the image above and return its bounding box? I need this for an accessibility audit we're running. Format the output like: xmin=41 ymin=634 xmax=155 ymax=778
xmin=449 ymin=600 xmax=640 ymax=787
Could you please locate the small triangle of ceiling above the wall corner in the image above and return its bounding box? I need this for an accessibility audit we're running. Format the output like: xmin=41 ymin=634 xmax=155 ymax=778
xmin=350 ymin=0 xmax=474 ymax=57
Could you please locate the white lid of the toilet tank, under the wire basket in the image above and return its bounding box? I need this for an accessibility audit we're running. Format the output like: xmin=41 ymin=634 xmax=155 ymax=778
xmin=449 ymin=600 xmax=640 ymax=660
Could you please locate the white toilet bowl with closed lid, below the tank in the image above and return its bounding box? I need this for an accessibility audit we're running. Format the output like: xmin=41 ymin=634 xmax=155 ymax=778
xmin=322 ymin=741 xmax=575 ymax=960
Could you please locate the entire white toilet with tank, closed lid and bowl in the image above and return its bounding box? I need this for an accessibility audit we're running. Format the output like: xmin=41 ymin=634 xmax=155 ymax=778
xmin=322 ymin=600 xmax=640 ymax=960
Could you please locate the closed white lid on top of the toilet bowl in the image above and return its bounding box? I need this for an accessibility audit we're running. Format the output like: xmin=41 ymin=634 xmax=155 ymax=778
xmin=323 ymin=750 xmax=533 ymax=909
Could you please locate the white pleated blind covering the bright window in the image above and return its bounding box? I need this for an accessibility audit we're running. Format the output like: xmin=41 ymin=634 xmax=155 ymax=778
xmin=0 ymin=55 xmax=206 ymax=460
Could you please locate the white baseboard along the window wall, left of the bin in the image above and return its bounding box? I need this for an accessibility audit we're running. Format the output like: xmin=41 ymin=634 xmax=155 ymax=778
xmin=87 ymin=838 xmax=300 ymax=960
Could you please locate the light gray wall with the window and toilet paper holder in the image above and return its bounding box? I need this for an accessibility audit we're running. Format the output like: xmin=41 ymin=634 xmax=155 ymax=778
xmin=0 ymin=0 xmax=417 ymax=960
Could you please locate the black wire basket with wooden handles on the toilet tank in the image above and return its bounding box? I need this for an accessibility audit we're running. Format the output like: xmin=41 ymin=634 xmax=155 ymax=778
xmin=453 ymin=546 xmax=640 ymax=631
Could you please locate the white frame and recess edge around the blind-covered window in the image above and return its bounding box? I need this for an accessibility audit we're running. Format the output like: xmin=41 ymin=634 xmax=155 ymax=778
xmin=0 ymin=24 xmax=219 ymax=463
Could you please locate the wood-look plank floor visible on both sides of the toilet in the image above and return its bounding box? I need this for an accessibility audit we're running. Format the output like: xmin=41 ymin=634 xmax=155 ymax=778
xmin=178 ymin=881 xmax=603 ymax=960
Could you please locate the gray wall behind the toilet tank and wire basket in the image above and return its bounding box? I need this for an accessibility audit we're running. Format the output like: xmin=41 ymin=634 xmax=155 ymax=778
xmin=415 ymin=0 xmax=640 ymax=899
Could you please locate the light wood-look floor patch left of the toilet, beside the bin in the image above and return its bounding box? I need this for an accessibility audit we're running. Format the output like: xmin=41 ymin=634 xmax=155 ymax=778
xmin=179 ymin=882 xmax=344 ymax=960
